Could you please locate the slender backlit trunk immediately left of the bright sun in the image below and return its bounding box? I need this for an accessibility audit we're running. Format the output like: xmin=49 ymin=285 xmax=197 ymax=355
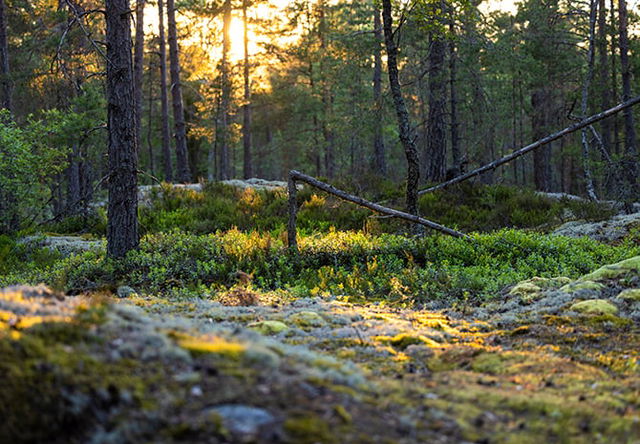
xmin=216 ymin=0 xmax=231 ymax=180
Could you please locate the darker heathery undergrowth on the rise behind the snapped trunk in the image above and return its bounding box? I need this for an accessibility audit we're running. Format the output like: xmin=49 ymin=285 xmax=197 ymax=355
xmin=44 ymin=183 xmax=613 ymax=236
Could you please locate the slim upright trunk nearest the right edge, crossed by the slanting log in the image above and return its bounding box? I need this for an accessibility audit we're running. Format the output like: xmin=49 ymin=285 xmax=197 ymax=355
xmin=618 ymin=0 xmax=638 ymax=201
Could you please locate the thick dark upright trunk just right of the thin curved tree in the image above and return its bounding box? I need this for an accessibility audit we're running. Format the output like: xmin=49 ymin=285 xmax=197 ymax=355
xmin=424 ymin=25 xmax=447 ymax=182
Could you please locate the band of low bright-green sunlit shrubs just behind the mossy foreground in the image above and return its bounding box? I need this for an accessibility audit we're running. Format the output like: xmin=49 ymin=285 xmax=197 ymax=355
xmin=0 ymin=229 xmax=640 ymax=305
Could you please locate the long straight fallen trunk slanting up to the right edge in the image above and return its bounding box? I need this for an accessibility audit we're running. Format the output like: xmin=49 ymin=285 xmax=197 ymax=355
xmin=418 ymin=96 xmax=640 ymax=195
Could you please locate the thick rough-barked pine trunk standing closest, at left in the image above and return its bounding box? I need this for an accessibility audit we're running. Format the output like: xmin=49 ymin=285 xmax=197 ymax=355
xmin=105 ymin=0 xmax=139 ymax=258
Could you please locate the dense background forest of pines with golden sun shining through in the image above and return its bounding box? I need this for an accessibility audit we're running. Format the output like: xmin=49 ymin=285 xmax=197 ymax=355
xmin=0 ymin=0 xmax=640 ymax=231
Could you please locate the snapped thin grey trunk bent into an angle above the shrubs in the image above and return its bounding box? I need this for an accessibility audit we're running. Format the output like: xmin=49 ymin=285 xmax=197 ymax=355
xmin=288 ymin=170 xmax=470 ymax=251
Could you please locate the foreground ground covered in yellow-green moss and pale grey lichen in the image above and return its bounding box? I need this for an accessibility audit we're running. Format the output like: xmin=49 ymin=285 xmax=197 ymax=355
xmin=0 ymin=253 xmax=640 ymax=443
